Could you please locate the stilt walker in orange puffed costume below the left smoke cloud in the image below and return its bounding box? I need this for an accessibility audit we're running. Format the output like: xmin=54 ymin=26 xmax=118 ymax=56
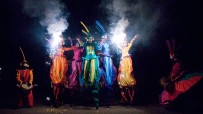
xmin=46 ymin=35 xmax=72 ymax=107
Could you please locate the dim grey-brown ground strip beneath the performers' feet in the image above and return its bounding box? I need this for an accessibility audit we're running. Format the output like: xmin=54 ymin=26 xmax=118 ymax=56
xmin=0 ymin=104 xmax=182 ymax=114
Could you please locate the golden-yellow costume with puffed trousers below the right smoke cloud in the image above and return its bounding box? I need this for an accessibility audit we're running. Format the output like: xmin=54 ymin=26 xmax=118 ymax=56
xmin=118 ymin=38 xmax=136 ymax=88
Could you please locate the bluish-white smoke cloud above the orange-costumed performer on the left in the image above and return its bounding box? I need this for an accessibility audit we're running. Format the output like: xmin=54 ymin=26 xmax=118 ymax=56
xmin=23 ymin=0 xmax=69 ymax=35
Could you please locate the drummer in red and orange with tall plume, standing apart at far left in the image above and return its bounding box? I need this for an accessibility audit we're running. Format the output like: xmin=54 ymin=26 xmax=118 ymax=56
xmin=16 ymin=47 xmax=34 ymax=108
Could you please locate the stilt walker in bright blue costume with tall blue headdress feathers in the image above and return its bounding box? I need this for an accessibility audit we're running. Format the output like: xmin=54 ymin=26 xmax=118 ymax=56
xmin=96 ymin=21 xmax=117 ymax=107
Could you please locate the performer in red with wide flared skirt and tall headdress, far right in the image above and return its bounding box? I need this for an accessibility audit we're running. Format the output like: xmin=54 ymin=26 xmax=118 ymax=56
xmin=160 ymin=41 xmax=203 ymax=104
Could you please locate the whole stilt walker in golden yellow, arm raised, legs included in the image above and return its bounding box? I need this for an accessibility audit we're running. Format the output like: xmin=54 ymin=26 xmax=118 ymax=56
xmin=118 ymin=35 xmax=137 ymax=104
